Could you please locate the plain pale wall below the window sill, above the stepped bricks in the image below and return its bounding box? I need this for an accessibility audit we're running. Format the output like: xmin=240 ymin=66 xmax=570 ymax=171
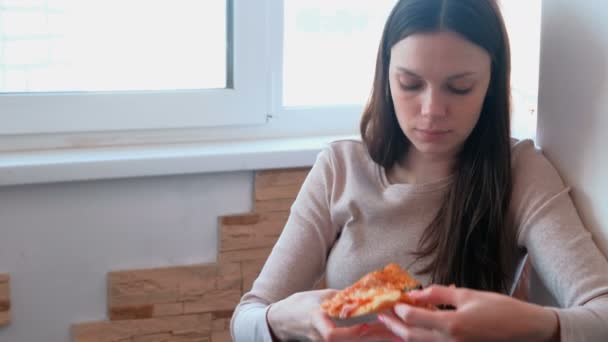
xmin=0 ymin=172 xmax=253 ymax=342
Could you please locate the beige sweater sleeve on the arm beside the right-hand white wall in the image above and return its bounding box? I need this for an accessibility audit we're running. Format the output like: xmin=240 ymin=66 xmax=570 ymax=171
xmin=513 ymin=140 xmax=608 ymax=342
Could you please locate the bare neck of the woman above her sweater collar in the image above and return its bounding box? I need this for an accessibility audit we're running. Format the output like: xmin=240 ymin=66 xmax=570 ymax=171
xmin=388 ymin=146 xmax=456 ymax=184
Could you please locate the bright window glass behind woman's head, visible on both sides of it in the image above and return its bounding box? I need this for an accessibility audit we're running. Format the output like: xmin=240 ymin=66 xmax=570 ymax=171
xmin=275 ymin=0 xmax=541 ymax=138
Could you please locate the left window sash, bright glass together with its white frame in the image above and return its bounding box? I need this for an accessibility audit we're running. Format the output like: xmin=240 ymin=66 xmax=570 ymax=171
xmin=0 ymin=0 xmax=269 ymax=135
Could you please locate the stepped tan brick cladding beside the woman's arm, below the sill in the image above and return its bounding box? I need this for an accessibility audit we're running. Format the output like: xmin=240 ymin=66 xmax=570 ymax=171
xmin=70 ymin=169 xmax=309 ymax=342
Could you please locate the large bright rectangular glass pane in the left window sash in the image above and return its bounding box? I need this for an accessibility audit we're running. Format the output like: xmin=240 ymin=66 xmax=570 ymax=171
xmin=0 ymin=0 xmax=227 ymax=92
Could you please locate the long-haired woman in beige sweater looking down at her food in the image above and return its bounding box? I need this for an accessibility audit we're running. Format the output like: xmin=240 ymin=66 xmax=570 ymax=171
xmin=231 ymin=0 xmax=608 ymax=341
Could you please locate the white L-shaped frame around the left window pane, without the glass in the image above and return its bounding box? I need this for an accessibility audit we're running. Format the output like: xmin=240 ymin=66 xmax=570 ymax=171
xmin=0 ymin=0 xmax=272 ymax=136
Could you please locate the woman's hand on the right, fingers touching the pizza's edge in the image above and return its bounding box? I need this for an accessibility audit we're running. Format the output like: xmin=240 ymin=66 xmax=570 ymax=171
xmin=378 ymin=286 xmax=559 ymax=342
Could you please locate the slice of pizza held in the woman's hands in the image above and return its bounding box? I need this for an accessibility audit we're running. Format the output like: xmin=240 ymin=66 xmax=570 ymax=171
xmin=321 ymin=263 xmax=428 ymax=319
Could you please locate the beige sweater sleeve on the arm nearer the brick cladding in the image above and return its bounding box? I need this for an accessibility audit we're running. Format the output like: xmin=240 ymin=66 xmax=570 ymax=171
xmin=230 ymin=149 xmax=339 ymax=342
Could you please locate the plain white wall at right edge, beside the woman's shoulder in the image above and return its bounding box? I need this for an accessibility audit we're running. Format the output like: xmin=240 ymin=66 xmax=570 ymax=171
xmin=537 ymin=0 xmax=608 ymax=301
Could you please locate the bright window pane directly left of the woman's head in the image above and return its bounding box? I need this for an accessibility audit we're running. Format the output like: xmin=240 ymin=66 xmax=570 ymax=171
xmin=283 ymin=0 xmax=396 ymax=107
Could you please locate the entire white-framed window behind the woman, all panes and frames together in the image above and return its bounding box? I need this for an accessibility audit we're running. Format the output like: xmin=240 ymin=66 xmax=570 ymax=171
xmin=0 ymin=0 xmax=540 ymax=146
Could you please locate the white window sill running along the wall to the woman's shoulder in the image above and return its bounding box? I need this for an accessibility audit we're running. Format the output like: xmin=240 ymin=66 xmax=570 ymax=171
xmin=0 ymin=135 xmax=356 ymax=186
